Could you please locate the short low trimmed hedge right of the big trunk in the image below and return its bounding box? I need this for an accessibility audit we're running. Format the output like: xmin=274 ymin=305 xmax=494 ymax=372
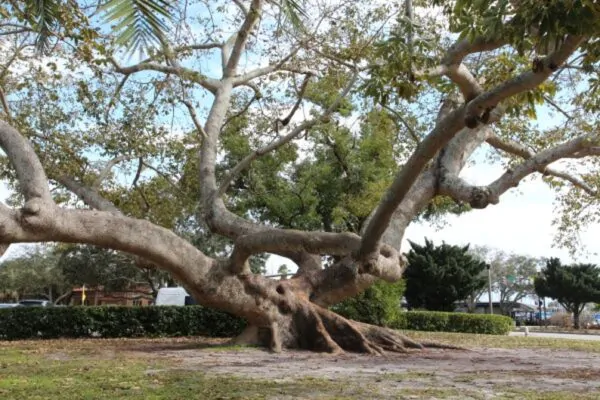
xmin=391 ymin=311 xmax=514 ymax=335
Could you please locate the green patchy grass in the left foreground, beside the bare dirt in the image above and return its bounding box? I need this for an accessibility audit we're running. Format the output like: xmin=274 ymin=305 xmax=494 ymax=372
xmin=0 ymin=340 xmax=371 ymax=400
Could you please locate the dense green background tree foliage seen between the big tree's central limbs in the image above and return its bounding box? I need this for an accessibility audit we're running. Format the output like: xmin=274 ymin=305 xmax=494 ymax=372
xmin=227 ymin=109 xmax=402 ymax=233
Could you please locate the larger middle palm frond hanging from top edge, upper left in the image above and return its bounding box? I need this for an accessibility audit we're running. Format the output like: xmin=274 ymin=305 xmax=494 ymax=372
xmin=102 ymin=0 xmax=174 ymax=53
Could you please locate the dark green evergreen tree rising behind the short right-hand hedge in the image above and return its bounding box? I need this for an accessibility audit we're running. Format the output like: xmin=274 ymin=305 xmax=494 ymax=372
xmin=404 ymin=239 xmax=486 ymax=311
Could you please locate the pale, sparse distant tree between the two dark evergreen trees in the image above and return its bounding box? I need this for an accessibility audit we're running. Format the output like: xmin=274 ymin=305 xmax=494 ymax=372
xmin=469 ymin=246 xmax=540 ymax=314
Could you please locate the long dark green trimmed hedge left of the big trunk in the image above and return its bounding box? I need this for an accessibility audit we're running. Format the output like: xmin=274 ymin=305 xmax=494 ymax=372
xmin=0 ymin=306 xmax=246 ymax=340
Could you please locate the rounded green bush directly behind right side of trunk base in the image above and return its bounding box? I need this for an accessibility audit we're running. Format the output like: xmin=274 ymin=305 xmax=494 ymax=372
xmin=332 ymin=281 xmax=405 ymax=326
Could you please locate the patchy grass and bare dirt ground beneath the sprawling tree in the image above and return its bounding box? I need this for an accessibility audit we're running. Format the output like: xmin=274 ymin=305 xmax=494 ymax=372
xmin=0 ymin=332 xmax=600 ymax=400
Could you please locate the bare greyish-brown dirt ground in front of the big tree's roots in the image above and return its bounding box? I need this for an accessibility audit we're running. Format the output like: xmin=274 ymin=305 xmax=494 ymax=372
xmin=123 ymin=338 xmax=600 ymax=399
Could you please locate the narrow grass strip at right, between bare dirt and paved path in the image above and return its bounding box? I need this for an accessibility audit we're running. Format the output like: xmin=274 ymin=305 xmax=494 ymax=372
xmin=402 ymin=331 xmax=600 ymax=353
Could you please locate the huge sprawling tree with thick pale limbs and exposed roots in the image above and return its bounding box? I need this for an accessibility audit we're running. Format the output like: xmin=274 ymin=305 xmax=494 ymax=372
xmin=0 ymin=0 xmax=600 ymax=353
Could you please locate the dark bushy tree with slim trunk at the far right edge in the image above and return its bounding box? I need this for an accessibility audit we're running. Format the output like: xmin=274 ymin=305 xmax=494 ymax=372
xmin=534 ymin=258 xmax=600 ymax=329
